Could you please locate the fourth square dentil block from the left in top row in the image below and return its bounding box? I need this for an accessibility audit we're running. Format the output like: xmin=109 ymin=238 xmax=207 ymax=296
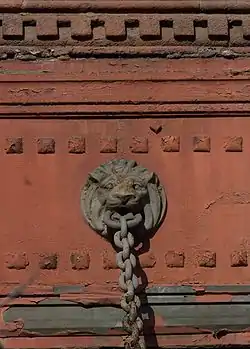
xmin=105 ymin=16 xmax=127 ymax=40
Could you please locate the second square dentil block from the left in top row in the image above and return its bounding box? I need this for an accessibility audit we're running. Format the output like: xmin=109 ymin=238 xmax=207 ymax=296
xmin=36 ymin=15 xmax=59 ymax=40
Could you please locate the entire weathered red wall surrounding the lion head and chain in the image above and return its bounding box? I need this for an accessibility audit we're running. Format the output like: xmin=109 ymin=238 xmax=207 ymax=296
xmin=0 ymin=0 xmax=250 ymax=349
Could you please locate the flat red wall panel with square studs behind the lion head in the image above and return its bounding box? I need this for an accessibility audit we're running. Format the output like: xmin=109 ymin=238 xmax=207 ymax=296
xmin=0 ymin=117 xmax=250 ymax=284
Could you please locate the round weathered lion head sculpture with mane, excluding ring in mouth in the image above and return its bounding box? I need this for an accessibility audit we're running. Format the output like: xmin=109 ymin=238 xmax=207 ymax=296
xmin=81 ymin=159 xmax=166 ymax=235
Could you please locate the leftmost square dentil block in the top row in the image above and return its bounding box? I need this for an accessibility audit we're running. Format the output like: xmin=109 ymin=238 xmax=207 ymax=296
xmin=2 ymin=14 xmax=24 ymax=40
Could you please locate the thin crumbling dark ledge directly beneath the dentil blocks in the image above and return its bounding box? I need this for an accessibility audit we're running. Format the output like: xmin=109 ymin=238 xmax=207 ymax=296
xmin=0 ymin=46 xmax=246 ymax=62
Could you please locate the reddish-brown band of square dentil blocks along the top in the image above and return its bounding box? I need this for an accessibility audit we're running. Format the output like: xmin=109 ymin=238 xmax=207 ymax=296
xmin=0 ymin=12 xmax=250 ymax=49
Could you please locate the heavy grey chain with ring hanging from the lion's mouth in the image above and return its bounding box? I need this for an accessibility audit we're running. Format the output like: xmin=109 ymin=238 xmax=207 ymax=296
xmin=104 ymin=211 xmax=146 ymax=349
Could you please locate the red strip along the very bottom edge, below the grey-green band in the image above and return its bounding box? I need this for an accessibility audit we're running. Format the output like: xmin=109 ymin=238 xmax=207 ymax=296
xmin=2 ymin=333 xmax=250 ymax=349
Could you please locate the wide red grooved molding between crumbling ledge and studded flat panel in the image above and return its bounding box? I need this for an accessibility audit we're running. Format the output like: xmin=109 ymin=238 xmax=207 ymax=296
xmin=0 ymin=58 xmax=250 ymax=118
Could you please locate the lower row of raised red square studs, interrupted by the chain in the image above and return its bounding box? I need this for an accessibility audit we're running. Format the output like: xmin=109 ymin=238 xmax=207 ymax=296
xmin=3 ymin=248 xmax=249 ymax=272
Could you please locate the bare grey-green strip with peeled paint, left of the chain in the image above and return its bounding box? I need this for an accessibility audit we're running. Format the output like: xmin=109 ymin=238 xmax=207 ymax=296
xmin=4 ymin=300 xmax=123 ymax=335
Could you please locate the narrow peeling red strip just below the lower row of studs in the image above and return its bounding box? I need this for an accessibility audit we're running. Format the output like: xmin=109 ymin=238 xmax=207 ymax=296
xmin=0 ymin=282 xmax=250 ymax=296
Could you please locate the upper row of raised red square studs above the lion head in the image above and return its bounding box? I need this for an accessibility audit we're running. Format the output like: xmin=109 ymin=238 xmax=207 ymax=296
xmin=0 ymin=135 xmax=247 ymax=155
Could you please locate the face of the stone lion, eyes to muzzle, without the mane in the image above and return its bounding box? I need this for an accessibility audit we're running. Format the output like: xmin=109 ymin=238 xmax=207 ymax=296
xmin=97 ymin=175 xmax=148 ymax=211
